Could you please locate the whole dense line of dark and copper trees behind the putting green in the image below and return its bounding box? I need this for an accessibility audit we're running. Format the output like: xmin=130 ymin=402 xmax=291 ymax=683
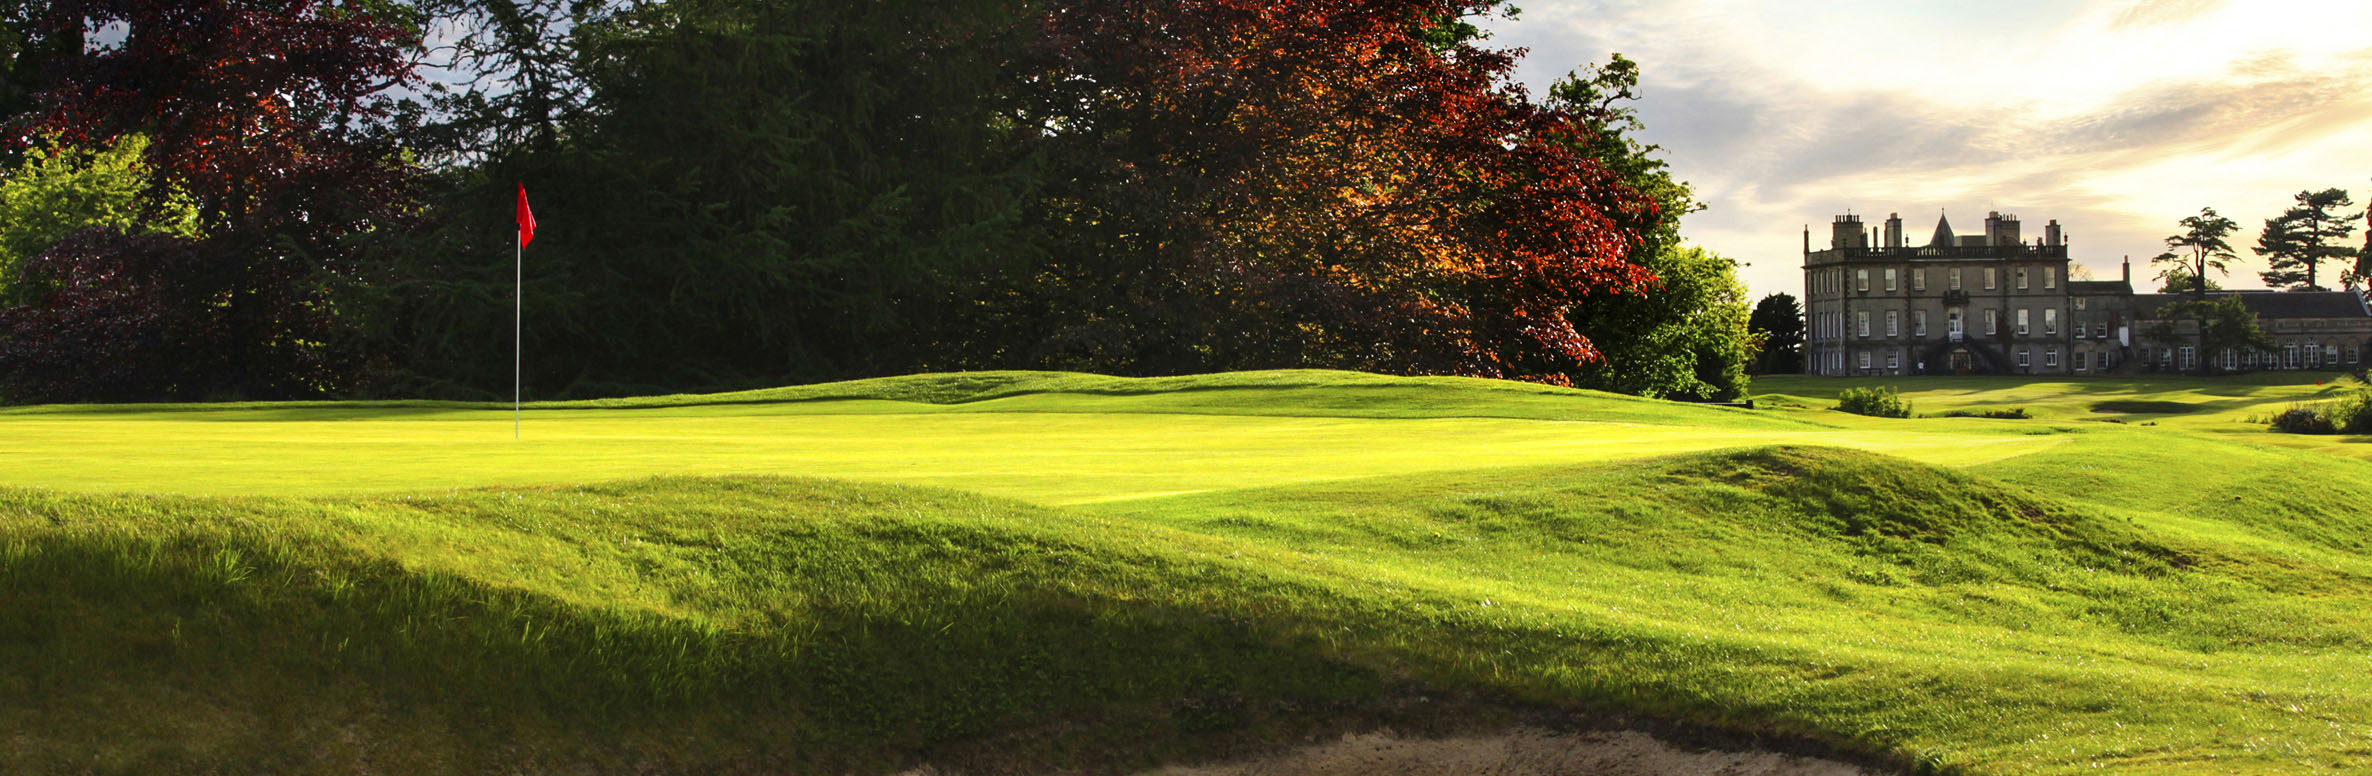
xmin=0 ymin=0 xmax=1751 ymax=401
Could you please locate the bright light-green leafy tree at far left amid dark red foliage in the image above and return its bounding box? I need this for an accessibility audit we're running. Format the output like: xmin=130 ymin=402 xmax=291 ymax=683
xmin=0 ymin=135 xmax=197 ymax=309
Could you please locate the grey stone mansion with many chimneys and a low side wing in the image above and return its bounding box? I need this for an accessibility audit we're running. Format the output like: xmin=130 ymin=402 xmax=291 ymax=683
xmin=1803 ymin=214 xmax=2372 ymax=375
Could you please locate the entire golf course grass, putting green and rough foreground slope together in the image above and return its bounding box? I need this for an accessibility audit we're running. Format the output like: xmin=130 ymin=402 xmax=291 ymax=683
xmin=0 ymin=370 xmax=2372 ymax=774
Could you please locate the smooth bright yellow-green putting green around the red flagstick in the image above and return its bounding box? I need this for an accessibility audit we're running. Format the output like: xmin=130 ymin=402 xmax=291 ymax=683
xmin=0 ymin=373 xmax=2061 ymax=503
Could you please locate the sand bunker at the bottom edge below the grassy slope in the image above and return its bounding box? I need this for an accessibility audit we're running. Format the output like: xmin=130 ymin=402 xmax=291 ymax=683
xmin=1119 ymin=729 xmax=1879 ymax=776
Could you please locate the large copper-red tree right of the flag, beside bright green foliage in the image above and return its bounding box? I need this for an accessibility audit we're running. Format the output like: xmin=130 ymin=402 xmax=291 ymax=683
xmin=1003 ymin=0 xmax=1658 ymax=382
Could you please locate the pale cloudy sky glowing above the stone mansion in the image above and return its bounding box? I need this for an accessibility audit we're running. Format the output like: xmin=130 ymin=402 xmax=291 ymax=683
xmin=1485 ymin=0 xmax=2372 ymax=299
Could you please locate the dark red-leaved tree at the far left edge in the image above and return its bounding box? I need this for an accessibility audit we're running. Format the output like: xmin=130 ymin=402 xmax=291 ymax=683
xmin=0 ymin=0 xmax=417 ymax=401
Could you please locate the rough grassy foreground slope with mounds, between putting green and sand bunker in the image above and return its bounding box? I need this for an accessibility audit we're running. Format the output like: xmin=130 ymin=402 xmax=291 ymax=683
xmin=0 ymin=441 xmax=2372 ymax=774
